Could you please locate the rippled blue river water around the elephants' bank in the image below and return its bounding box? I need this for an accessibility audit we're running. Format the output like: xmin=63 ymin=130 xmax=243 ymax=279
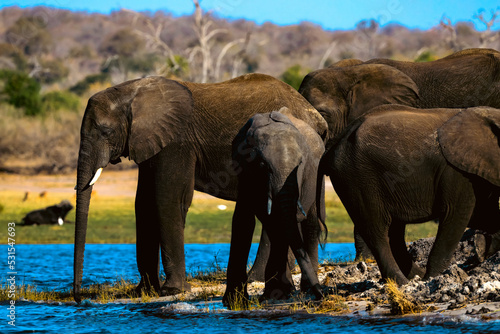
xmin=0 ymin=243 xmax=500 ymax=334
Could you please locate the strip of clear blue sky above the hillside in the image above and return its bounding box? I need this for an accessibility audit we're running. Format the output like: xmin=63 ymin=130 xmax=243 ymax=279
xmin=0 ymin=0 xmax=500 ymax=30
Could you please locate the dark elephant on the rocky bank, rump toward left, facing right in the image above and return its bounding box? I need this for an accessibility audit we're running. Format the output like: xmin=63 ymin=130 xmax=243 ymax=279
xmin=321 ymin=105 xmax=500 ymax=284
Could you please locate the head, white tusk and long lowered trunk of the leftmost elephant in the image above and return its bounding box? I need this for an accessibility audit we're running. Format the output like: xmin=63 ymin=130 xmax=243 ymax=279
xmin=73 ymin=77 xmax=193 ymax=301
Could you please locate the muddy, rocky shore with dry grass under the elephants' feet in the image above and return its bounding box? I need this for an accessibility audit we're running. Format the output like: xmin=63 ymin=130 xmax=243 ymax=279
xmin=113 ymin=231 xmax=500 ymax=321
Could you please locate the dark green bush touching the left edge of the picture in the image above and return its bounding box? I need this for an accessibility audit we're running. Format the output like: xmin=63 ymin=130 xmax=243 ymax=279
xmin=0 ymin=70 xmax=42 ymax=116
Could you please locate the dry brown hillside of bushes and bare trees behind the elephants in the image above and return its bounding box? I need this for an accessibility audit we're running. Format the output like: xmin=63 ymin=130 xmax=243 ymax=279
xmin=0 ymin=0 xmax=500 ymax=116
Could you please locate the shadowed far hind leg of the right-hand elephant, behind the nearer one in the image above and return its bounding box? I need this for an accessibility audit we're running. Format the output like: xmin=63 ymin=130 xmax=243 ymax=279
xmin=389 ymin=222 xmax=425 ymax=279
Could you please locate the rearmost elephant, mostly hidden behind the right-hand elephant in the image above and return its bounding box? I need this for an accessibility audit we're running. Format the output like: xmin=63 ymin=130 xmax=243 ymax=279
xmin=299 ymin=49 xmax=500 ymax=258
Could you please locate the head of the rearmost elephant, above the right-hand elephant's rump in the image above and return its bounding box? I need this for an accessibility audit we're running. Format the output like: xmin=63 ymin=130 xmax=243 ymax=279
xmin=299 ymin=64 xmax=419 ymax=145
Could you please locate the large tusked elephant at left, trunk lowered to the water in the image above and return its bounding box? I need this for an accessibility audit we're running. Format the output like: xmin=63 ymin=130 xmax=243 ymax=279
xmin=74 ymin=74 xmax=327 ymax=301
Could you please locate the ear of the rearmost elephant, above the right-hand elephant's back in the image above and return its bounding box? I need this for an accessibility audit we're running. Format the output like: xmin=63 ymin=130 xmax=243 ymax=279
xmin=346 ymin=64 xmax=419 ymax=121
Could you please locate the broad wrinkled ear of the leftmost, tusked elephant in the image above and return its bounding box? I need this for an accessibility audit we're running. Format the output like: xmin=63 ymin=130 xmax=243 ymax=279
xmin=129 ymin=76 xmax=193 ymax=164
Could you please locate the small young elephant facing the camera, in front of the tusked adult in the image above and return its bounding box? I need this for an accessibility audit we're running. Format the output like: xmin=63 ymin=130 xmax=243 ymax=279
xmin=223 ymin=108 xmax=326 ymax=307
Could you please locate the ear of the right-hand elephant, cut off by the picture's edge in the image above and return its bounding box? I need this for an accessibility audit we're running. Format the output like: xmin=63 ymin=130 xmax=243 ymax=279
xmin=437 ymin=107 xmax=500 ymax=186
